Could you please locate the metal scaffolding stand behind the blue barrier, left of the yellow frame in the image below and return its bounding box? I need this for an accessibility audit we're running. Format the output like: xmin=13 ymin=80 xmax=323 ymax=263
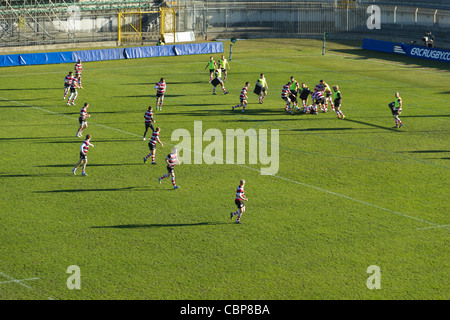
xmin=0 ymin=0 xmax=161 ymax=47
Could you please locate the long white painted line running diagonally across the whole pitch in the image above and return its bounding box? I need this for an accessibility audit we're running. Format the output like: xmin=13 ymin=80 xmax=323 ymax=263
xmin=0 ymin=97 xmax=449 ymax=230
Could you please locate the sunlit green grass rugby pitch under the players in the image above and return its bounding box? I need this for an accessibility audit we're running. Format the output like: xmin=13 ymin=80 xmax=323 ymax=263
xmin=0 ymin=39 xmax=450 ymax=300
